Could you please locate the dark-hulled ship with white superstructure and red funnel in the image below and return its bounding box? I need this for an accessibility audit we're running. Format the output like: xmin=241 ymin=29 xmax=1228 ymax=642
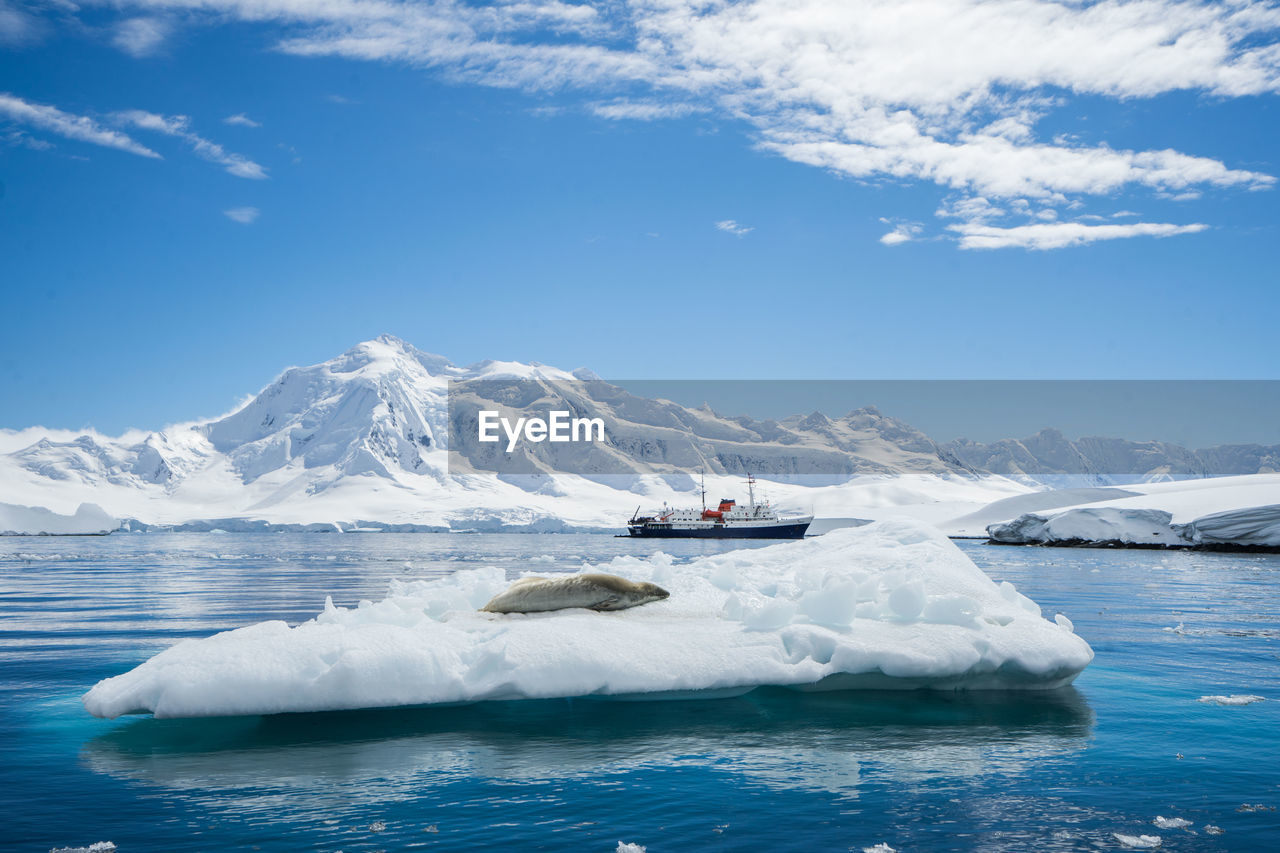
xmin=627 ymin=474 xmax=813 ymax=539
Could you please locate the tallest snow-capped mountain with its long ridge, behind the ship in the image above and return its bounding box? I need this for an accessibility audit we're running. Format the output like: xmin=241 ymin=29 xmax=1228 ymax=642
xmin=0 ymin=336 xmax=998 ymax=529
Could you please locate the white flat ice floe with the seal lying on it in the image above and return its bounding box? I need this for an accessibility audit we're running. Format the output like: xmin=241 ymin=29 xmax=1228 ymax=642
xmin=83 ymin=520 xmax=1093 ymax=717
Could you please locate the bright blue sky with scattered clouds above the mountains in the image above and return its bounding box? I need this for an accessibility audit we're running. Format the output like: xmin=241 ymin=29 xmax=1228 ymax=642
xmin=0 ymin=0 xmax=1280 ymax=433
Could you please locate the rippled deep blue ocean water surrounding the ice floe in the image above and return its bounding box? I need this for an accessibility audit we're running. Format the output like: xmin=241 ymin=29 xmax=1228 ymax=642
xmin=0 ymin=534 xmax=1280 ymax=853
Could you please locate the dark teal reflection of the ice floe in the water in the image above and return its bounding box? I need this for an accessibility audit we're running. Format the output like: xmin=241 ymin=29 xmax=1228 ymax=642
xmin=82 ymin=688 xmax=1093 ymax=808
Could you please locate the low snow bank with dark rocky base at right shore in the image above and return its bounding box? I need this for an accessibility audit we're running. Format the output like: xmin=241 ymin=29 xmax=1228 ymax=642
xmin=987 ymin=474 xmax=1280 ymax=549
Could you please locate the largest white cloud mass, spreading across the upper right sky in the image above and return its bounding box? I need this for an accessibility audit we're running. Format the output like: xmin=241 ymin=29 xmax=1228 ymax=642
xmin=94 ymin=0 xmax=1280 ymax=245
